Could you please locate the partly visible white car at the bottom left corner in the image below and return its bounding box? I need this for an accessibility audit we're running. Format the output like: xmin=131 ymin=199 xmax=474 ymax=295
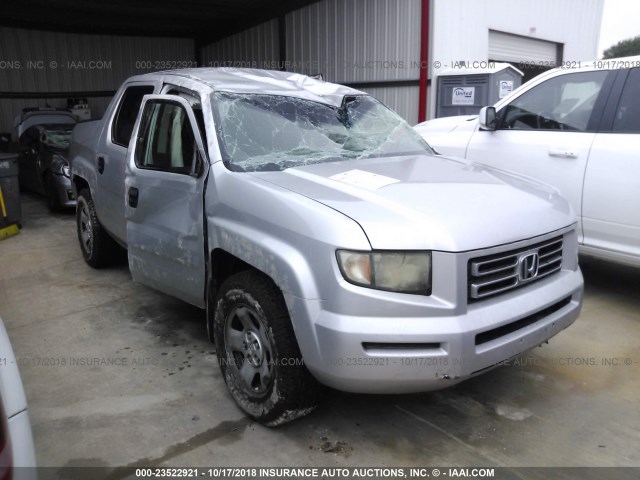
xmin=0 ymin=318 xmax=36 ymax=480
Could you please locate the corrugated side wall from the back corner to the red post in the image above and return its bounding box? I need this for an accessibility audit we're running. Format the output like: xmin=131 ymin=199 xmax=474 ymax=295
xmin=202 ymin=0 xmax=421 ymax=123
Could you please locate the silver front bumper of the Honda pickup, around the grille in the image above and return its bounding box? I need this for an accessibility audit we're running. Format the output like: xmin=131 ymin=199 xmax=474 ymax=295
xmin=289 ymin=229 xmax=584 ymax=393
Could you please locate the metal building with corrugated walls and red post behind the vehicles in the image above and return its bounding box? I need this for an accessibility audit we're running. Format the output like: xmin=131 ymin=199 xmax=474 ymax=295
xmin=0 ymin=0 xmax=604 ymax=132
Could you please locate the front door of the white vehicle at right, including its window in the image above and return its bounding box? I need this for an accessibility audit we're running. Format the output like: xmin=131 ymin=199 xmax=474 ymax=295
xmin=466 ymin=71 xmax=609 ymax=241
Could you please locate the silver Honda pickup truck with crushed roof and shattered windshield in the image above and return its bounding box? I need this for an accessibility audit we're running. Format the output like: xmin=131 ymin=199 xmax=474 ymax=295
xmin=70 ymin=69 xmax=583 ymax=426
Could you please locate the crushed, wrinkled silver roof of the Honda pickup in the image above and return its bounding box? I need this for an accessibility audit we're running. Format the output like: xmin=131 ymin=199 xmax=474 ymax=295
xmin=138 ymin=68 xmax=366 ymax=106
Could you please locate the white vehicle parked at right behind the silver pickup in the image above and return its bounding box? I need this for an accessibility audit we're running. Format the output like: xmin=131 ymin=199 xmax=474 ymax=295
xmin=415 ymin=57 xmax=640 ymax=266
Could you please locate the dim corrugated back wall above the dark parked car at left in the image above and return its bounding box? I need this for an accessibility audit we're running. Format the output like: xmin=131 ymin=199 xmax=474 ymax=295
xmin=0 ymin=27 xmax=195 ymax=135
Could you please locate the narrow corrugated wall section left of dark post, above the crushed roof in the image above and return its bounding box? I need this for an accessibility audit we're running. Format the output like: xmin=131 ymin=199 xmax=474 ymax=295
xmin=200 ymin=20 xmax=280 ymax=69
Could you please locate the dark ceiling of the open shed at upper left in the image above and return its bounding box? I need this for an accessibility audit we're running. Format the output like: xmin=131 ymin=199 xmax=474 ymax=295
xmin=0 ymin=0 xmax=318 ymax=44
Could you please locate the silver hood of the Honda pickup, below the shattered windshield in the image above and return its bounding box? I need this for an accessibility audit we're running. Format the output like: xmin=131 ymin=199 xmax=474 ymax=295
xmin=255 ymin=155 xmax=575 ymax=252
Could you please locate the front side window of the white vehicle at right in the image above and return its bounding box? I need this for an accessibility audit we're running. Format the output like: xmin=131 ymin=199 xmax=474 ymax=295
xmin=500 ymin=71 xmax=608 ymax=132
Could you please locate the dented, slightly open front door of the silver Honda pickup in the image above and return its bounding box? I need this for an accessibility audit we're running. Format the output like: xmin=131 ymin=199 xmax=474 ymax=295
xmin=125 ymin=95 xmax=209 ymax=307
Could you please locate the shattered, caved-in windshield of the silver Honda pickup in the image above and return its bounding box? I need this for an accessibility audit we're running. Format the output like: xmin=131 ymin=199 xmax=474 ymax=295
xmin=213 ymin=92 xmax=431 ymax=172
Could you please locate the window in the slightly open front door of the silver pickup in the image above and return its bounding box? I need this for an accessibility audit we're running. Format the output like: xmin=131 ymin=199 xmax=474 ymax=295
xmin=135 ymin=102 xmax=197 ymax=174
